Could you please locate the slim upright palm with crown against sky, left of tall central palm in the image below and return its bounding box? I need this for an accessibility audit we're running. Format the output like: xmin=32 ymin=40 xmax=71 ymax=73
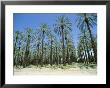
xmin=38 ymin=24 xmax=49 ymax=66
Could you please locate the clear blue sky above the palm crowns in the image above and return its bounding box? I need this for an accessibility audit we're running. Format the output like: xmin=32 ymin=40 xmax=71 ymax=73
xmin=13 ymin=13 xmax=96 ymax=47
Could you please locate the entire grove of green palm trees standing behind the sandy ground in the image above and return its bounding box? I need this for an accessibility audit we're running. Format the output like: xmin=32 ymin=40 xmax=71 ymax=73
xmin=13 ymin=13 xmax=97 ymax=67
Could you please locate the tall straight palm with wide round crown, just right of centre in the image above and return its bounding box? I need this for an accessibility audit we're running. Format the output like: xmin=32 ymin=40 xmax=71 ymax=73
xmin=54 ymin=16 xmax=72 ymax=65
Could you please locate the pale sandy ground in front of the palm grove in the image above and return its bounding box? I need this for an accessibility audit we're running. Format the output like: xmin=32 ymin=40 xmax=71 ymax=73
xmin=14 ymin=65 xmax=97 ymax=75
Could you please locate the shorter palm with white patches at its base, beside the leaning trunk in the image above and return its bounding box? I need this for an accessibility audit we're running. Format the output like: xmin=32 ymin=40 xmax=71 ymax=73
xmin=78 ymin=29 xmax=93 ymax=64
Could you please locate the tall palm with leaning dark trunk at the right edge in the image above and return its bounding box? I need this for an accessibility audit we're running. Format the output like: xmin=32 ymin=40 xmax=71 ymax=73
xmin=77 ymin=13 xmax=97 ymax=59
